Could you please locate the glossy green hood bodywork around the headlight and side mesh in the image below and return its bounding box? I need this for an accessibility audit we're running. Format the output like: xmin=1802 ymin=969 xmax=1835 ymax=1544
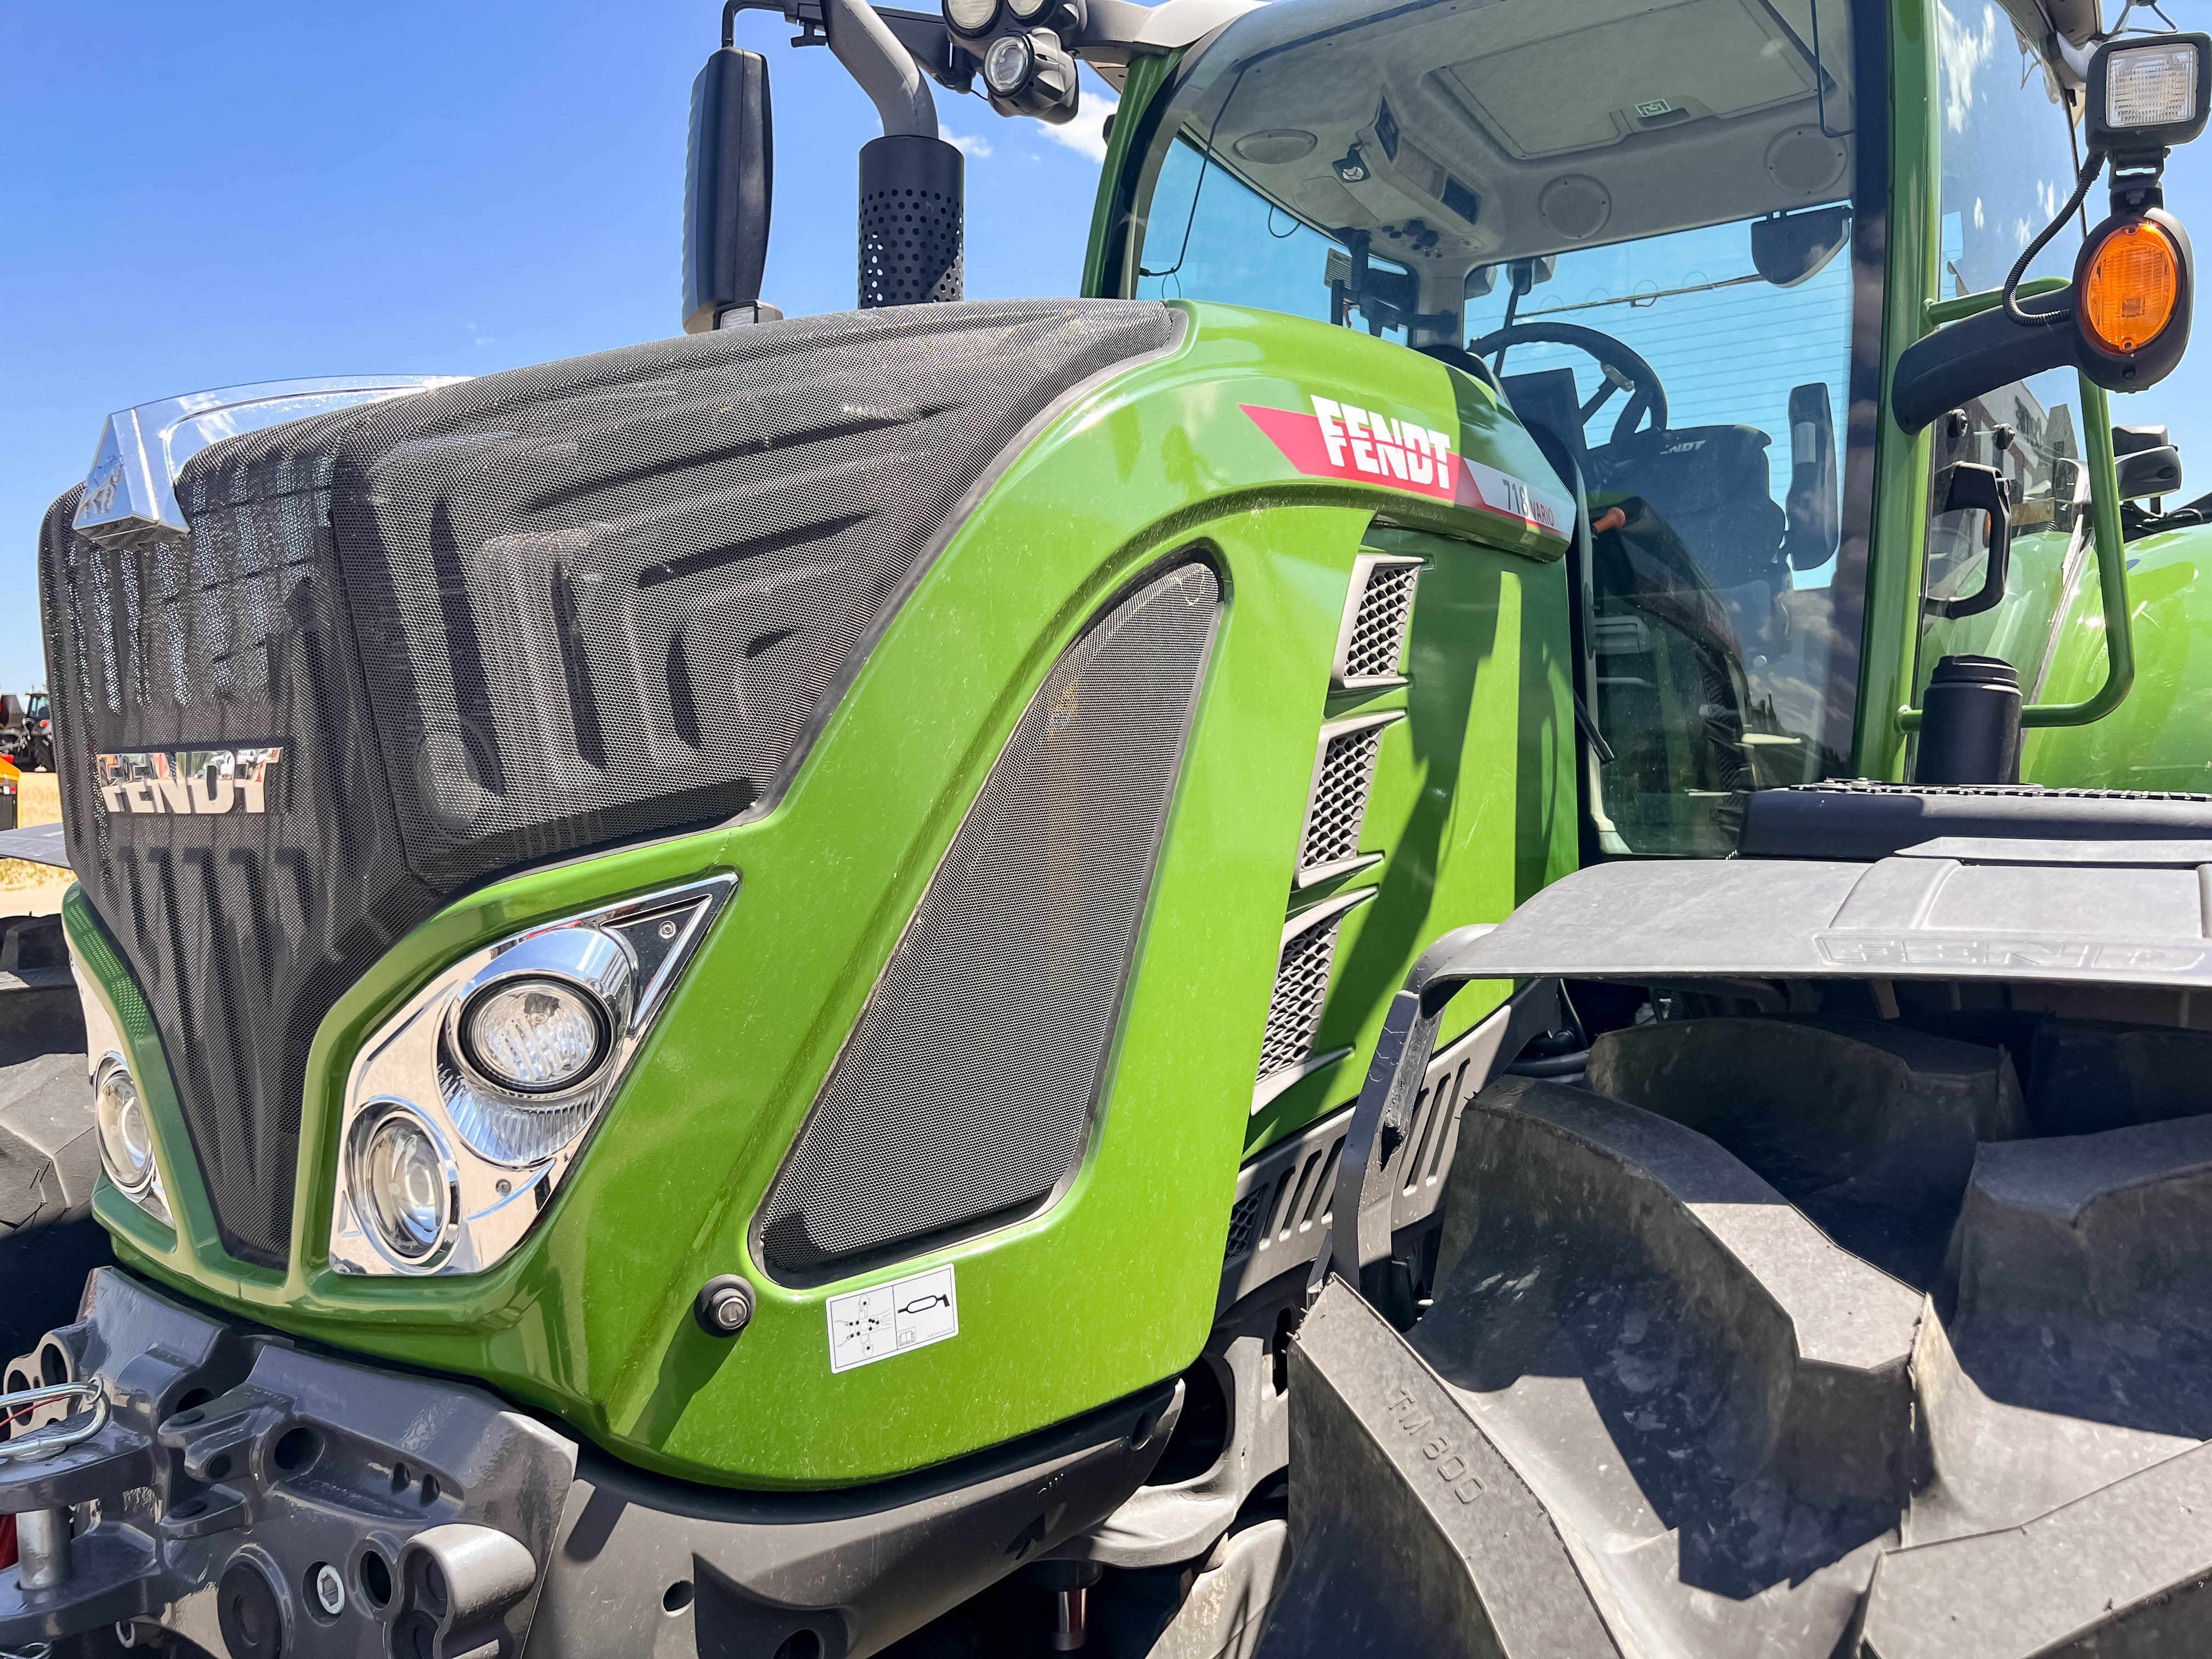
xmin=66 ymin=305 xmax=1575 ymax=1487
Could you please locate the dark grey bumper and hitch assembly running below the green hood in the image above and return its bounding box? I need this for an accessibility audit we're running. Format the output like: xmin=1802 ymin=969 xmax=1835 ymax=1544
xmin=0 ymin=1267 xmax=1181 ymax=1659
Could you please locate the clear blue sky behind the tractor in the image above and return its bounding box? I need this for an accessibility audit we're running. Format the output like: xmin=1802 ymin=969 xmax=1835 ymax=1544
xmin=0 ymin=0 xmax=2212 ymax=690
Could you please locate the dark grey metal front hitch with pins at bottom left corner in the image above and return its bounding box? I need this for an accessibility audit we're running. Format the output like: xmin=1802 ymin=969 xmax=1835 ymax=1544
xmin=0 ymin=1267 xmax=575 ymax=1659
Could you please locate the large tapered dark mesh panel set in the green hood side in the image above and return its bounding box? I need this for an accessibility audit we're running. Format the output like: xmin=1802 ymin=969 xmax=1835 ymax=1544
xmin=759 ymin=564 xmax=1221 ymax=1278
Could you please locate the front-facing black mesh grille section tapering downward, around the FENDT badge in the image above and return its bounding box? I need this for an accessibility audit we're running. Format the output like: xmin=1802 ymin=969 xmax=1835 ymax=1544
xmin=40 ymin=458 xmax=438 ymax=1267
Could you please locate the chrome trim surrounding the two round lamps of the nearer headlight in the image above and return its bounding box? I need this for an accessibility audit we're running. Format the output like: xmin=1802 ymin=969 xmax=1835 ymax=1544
xmin=330 ymin=876 xmax=737 ymax=1276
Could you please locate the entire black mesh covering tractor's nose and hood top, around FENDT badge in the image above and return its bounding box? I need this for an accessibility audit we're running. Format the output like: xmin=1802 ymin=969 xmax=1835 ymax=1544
xmin=40 ymin=301 xmax=1181 ymax=1265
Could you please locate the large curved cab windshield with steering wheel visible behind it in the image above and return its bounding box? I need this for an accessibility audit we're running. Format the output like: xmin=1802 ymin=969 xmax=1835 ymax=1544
xmin=1119 ymin=0 xmax=1878 ymax=854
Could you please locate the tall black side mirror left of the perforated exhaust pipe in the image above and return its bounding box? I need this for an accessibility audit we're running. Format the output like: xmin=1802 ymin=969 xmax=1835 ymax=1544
xmin=684 ymin=47 xmax=781 ymax=334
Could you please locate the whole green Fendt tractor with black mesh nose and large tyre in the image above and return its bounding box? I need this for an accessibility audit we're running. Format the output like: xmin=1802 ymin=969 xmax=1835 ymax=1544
xmin=13 ymin=0 xmax=2212 ymax=1659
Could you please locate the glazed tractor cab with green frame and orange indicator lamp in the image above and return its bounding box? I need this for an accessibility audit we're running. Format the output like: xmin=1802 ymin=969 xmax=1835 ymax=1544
xmin=1066 ymin=0 xmax=2201 ymax=832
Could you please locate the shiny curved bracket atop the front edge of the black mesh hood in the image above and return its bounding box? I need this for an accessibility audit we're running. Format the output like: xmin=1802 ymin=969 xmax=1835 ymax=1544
xmin=75 ymin=374 xmax=469 ymax=546
